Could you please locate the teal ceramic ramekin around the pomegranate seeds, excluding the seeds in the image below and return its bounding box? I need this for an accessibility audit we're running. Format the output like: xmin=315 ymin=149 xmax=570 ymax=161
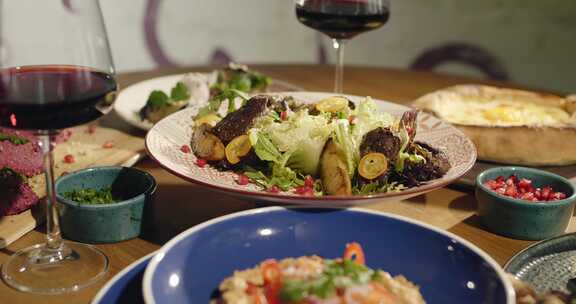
xmin=476 ymin=167 xmax=576 ymax=240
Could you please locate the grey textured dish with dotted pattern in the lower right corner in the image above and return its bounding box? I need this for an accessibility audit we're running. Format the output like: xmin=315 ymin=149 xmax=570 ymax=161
xmin=504 ymin=233 xmax=576 ymax=293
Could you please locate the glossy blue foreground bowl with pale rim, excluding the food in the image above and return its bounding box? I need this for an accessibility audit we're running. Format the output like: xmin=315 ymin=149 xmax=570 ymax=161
xmin=143 ymin=207 xmax=514 ymax=304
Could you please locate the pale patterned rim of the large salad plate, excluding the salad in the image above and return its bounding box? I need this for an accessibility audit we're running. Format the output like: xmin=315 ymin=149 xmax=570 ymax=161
xmin=146 ymin=92 xmax=476 ymax=206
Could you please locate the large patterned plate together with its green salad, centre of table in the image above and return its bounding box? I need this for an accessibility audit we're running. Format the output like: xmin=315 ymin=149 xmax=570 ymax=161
xmin=146 ymin=92 xmax=476 ymax=206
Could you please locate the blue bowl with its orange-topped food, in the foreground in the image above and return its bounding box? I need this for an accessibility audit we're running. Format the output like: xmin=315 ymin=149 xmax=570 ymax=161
xmin=143 ymin=207 xmax=514 ymax=304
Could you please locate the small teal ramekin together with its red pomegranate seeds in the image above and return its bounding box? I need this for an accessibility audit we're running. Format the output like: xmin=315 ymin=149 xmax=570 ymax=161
xmin=476 ymin=167 xmax=576 ymax=240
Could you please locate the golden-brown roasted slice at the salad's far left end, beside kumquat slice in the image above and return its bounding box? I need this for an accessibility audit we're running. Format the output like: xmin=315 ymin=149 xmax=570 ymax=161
xmin=190 ymin=124 xmax=225 ymax=161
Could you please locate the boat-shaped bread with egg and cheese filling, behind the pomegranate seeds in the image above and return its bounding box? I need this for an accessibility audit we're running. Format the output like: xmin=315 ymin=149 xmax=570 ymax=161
xmin=414 ymin=84 xmax=576 ymax=166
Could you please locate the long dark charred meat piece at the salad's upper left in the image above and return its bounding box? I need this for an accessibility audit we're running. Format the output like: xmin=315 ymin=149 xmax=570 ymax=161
xmin=212 ymin=95 xmax=276 ymax=145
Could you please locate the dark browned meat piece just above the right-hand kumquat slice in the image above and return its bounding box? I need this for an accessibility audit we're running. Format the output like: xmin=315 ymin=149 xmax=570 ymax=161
xmin=360 ymin=127 xmax=402 ymax=161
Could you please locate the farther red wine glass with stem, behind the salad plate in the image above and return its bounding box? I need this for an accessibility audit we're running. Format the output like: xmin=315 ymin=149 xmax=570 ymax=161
xmin=295 ymin=0 xmax=390 ymax=93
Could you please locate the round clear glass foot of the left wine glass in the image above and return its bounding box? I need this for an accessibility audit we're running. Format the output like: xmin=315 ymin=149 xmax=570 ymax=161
xmin=2 ymin=242 xmax=108 ymax=294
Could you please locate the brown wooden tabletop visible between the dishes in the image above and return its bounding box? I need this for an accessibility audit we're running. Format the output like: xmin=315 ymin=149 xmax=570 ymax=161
xmin=0 ymin=65 xmax=560 ymax=304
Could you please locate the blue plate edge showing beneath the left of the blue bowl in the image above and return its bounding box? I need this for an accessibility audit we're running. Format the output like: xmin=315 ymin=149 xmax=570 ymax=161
xmin=91 ymin=252 xmax=155 ymax=304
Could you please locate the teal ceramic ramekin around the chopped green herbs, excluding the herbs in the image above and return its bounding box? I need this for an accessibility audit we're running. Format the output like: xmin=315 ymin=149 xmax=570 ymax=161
xmin=56 ymin=166 xmax=156 ymax=243
